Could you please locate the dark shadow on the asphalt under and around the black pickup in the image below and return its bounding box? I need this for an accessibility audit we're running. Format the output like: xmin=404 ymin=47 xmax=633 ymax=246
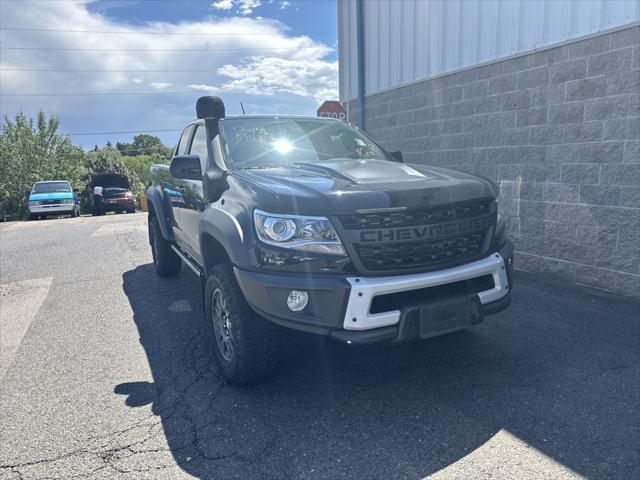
xmin=115 ymin=265 xmax=639 ymax=479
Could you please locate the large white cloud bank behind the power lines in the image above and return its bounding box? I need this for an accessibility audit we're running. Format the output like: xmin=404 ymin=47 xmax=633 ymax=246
xmin=0 ymin=2 xmax=337 ymax=146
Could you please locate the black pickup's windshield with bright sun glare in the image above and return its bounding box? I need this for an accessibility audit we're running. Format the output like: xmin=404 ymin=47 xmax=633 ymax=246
xmin=220 ymin=117 xmax=389 ymax=169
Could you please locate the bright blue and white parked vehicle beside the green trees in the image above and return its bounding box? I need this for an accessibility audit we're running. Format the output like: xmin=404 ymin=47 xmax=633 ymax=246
xmin=26 ymin=180 xmax=80 ymax=220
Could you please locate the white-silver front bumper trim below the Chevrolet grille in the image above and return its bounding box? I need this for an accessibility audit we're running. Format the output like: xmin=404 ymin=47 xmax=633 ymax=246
xmin=343 ymin=253 xmax=509 ymax=330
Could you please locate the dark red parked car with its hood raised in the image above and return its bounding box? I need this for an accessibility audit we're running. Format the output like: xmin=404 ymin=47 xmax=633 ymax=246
xmin=89 ymin=173 xmax=136 ymax=215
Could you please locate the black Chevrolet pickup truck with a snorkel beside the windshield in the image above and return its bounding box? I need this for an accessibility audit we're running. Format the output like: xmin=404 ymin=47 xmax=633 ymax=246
xmin=147 ymin=97 xmax=513 ymax=384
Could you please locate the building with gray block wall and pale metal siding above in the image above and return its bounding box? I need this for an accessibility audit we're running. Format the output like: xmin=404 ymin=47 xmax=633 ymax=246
xmin=338 ymin=0 xmax=640 ymax=296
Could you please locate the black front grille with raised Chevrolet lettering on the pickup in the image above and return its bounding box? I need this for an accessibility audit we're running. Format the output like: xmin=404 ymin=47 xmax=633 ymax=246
xmin=338 ymin=201 xmax=496 ymax=274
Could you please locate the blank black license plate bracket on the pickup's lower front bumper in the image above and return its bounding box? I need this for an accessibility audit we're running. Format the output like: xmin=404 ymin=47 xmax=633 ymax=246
xmin=418 ymin=294 xmax=482 ymax=339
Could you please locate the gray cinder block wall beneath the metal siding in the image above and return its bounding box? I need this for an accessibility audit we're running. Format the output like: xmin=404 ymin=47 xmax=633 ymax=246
xmin=348 ymin=26 xmax=640 ymax=297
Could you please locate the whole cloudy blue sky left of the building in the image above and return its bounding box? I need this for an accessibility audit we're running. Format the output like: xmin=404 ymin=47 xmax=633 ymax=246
xmin=0 ymin=0 xmax=338 ymax=148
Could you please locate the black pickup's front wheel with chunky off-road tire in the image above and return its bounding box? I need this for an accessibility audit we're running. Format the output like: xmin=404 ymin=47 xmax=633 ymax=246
xmin=205 ymin=263 xmax=280 ymax=385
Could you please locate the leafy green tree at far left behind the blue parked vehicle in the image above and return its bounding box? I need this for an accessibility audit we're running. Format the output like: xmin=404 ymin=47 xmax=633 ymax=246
xmin=0 ymin=111 xmax=86 ymax=219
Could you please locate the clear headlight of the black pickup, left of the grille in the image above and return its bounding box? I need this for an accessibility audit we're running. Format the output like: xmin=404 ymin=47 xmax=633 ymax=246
xmin=253 ymin=210 xmax=345 ymax=255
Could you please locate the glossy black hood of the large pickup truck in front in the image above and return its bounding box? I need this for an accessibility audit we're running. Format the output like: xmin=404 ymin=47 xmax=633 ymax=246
xmin=232 ymin=159 xmax=498 ymax=215
